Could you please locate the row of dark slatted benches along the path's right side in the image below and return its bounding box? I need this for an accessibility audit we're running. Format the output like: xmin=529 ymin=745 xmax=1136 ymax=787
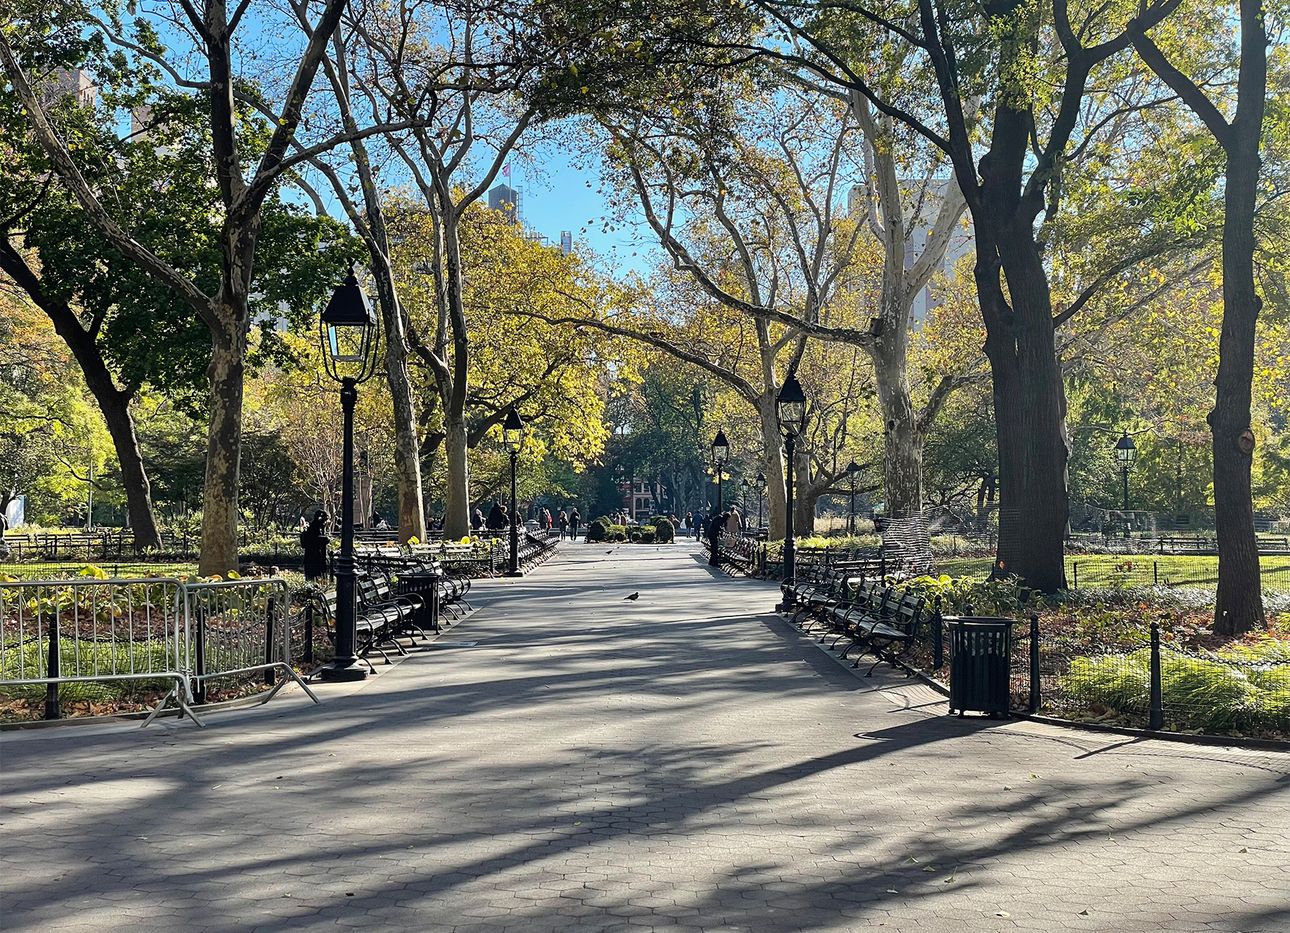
xmin=782 ymin=557 xmax=940 ymax=676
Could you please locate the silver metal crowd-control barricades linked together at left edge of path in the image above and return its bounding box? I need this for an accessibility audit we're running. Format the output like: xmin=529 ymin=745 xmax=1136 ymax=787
xmin=0 ymin=577 xmax=316 ymax=725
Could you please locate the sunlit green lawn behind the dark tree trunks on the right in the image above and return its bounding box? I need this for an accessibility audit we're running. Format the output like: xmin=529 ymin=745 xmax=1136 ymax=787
xmin=937 ymin=554 xmax=1290 ymax=592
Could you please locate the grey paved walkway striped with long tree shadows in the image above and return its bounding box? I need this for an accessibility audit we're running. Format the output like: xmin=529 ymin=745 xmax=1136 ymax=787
xmin=0 ymin=543 xmax=1290 ymax=933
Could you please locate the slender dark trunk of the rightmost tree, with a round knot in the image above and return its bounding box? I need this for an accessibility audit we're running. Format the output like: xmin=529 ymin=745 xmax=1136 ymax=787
xmin=1209 ymin=40 xmax=1267 ymax=635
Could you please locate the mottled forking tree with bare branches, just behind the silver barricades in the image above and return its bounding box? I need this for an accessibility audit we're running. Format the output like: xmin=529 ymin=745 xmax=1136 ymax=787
xmin=0 ymin=0 xmax=387 ymax=573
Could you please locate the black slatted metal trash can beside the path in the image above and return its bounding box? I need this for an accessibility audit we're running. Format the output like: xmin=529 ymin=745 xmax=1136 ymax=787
xmin=944 ymin=616 xmax=1017 ymax=716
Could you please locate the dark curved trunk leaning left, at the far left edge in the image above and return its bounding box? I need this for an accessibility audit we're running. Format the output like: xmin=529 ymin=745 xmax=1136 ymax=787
xmin=0 ymin=241 xmax=161 ymax=550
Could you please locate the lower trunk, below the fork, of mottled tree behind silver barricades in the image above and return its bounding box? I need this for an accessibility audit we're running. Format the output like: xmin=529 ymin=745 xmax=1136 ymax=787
xmin=197 ymin=317 xmax=246 ymax=576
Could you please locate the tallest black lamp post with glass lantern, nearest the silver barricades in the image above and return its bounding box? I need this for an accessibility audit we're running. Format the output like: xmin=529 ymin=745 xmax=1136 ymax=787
xmin=320 ymin=267 xmax=381 ymax=681
